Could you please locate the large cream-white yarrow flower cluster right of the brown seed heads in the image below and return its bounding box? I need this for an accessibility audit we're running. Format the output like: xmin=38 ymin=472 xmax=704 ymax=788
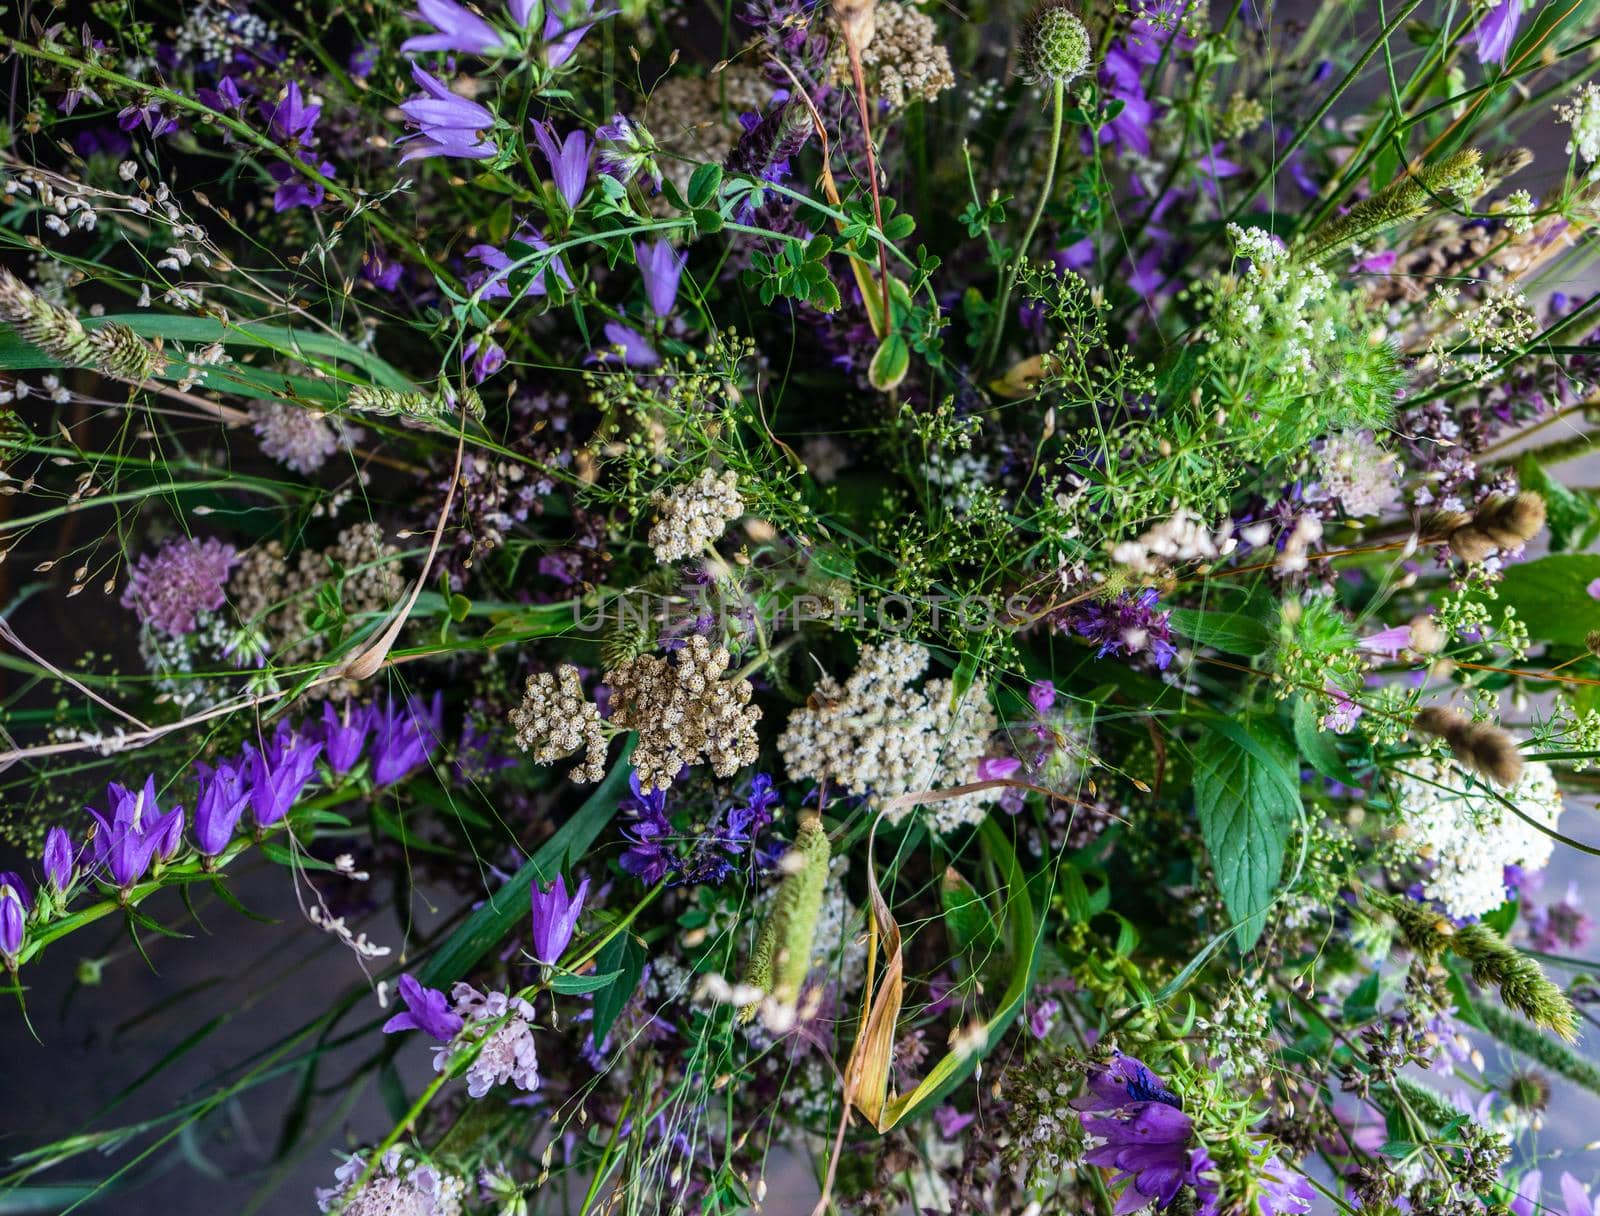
xmin=778 ymin=638 xmax=998 ymax=832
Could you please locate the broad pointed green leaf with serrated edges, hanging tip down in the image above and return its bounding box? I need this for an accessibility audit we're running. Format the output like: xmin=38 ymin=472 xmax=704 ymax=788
xmin=1194 ymin=718 xmax=1299 ymax=950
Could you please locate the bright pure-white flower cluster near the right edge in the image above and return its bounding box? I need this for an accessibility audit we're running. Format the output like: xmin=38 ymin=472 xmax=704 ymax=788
xmin=1395 ymin=760 xmax=1562 ymax=918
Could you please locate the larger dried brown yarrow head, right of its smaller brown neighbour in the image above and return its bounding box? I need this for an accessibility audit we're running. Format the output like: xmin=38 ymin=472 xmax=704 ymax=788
xmin=605 ymin=634 xmax=762 ymax=794
